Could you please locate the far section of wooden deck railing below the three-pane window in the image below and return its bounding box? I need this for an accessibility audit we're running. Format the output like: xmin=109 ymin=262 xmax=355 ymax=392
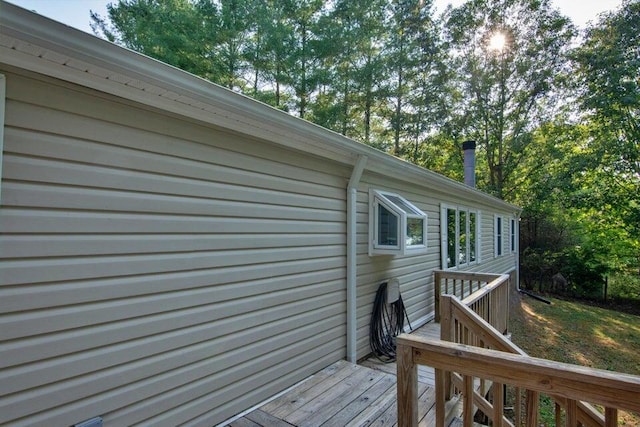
xmin=433 ymin=270 xmax=511 ymax=333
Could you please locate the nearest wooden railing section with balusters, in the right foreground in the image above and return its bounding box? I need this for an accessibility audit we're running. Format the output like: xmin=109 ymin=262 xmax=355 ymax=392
xmin=397 ymin=334 xmax=640 ymax=427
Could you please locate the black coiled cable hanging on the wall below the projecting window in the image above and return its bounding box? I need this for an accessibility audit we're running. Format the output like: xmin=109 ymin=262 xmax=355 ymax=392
xmin=369 ymin=282 xmax=412 ymax=363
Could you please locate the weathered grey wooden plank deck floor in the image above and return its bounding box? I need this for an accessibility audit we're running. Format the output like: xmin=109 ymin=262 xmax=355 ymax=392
xmin=229 ymin=323 xmax=455 ymax=427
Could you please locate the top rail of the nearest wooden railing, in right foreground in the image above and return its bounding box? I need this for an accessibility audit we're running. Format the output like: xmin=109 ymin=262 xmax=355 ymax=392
xmin=397 ymin=334 xmax=640 ymax=412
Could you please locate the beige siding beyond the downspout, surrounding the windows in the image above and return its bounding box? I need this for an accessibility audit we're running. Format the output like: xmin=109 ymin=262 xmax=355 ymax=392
xmin=357 ymin=173 xmax=516 ymax=358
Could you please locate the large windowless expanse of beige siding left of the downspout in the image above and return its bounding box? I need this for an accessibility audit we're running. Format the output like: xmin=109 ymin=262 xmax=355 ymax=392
xmin=0 ymin=69 xmax=349 ymax=426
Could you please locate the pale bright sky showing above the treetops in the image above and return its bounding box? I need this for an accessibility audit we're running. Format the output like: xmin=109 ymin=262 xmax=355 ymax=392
xmin=5 ymin=0 xmax=622 ymax=33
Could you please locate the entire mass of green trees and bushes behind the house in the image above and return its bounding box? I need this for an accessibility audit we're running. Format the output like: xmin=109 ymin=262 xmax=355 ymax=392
xmin=92 ymin=0 xmax=640 ymax=284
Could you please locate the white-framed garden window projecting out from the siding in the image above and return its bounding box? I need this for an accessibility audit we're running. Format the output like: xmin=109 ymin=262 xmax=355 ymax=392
xmin=369 ymin=190 xmax=427 ymax=255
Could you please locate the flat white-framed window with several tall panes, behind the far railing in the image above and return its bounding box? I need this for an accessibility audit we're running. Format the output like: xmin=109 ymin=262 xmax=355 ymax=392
xmin=440 ymin=205 xmax=480 ymax=269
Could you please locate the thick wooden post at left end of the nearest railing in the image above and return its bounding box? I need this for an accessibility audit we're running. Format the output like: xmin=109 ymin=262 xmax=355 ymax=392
xmin=396 ymin=343 xmax=418 ymax=427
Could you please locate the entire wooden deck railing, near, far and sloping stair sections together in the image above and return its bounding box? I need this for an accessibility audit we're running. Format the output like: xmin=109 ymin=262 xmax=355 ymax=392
xmin=397 ymin=272 xmax=640 ymax=427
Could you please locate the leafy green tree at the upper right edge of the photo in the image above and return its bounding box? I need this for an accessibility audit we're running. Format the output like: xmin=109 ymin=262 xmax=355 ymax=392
xmin=573 ymin=0 xmax=640 ymax=181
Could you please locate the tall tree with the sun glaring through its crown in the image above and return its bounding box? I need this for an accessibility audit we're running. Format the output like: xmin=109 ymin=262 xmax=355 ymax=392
xmin=446 ymin=0 xmax=574 ymax=200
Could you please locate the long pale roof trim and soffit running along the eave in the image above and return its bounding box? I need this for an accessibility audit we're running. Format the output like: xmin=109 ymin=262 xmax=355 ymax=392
xmin=0 ymin=0 xmax=520 ymax=212
